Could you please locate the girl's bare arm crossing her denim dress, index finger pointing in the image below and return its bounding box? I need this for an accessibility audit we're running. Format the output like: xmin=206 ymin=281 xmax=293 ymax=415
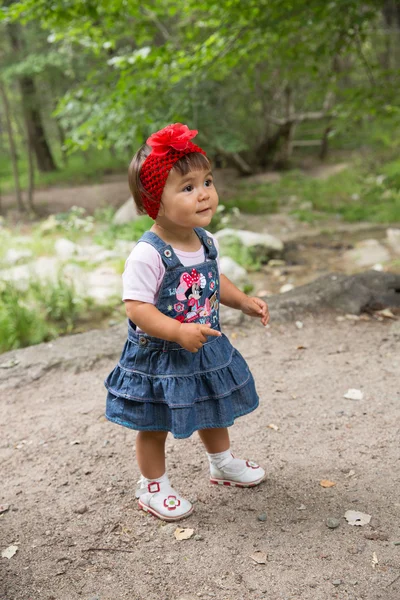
xmin=125 ymin=300 xmax=221 ymax=352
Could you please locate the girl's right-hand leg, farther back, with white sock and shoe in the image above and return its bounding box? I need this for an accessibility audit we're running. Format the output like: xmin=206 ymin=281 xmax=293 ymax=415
xmin=199 ymin=428 xmax=265 ymax=487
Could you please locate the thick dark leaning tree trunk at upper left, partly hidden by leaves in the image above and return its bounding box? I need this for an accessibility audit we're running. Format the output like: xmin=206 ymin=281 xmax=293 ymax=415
xmin=7 ymin=23 xmax=57 ymax=172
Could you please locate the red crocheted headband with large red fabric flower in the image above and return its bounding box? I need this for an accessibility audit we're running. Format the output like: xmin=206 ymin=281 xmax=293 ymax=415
xmin=140 ymin=123 xmax=206 ymax=219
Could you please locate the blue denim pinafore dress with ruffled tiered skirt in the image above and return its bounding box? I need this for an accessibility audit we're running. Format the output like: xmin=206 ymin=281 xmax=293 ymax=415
xmin=105 ymin=228 xmax=258 ymax=438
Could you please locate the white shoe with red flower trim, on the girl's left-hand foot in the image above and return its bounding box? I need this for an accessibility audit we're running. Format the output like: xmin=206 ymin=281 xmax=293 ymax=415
xmin=136 ymin=477 xmax=193 ymax=521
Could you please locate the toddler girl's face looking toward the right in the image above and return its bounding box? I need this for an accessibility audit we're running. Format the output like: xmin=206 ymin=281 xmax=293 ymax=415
xmin=157 ymin=169 xmax=218 ymax=229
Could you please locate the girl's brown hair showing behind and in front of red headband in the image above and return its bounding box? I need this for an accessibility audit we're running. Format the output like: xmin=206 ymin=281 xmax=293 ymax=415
xmin=128 ymin=144 xmax=211 ymax=215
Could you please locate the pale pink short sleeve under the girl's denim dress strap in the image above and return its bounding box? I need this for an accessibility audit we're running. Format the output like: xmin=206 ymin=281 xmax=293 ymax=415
xmin=122 ymin=242 xmax=165 ymax=304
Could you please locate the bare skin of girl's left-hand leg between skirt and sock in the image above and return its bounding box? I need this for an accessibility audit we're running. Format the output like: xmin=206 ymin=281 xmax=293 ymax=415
xmin=136 ymin=431 xmax=168 ymax=479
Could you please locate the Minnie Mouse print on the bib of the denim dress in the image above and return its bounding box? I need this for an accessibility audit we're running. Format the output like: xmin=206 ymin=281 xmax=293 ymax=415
xmin=174 ymin=269 xmax=217 ymax=323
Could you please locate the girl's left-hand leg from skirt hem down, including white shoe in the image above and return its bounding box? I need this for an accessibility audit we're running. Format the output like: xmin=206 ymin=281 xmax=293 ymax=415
xmin=136 ymin=431 xmax=193 ymax=521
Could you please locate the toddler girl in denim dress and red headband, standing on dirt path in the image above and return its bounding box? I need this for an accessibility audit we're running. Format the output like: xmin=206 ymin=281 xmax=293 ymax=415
xmin=105 ymin=123 xmax=269 ymax=521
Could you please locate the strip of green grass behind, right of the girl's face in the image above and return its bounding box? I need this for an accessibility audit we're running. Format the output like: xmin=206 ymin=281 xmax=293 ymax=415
xmin=224 ymin=159 xmax=400 ymax=223
